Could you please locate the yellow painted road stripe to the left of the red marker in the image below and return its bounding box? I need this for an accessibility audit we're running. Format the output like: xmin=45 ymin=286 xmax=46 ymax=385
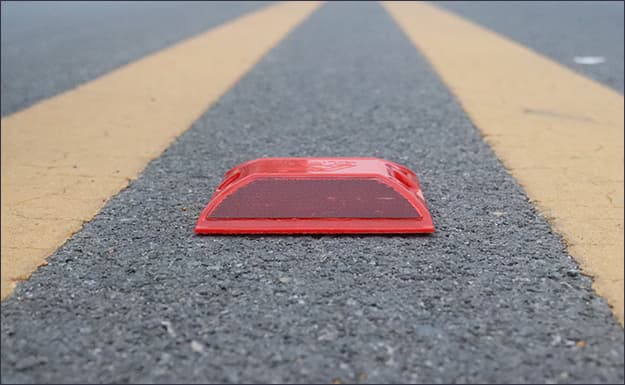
xmin=1 ymin=2 xmax=319 ymax=299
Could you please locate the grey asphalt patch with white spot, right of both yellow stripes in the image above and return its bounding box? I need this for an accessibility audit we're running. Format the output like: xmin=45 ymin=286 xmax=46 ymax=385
xmin=438 ymin=1 xmax=625 ymax=93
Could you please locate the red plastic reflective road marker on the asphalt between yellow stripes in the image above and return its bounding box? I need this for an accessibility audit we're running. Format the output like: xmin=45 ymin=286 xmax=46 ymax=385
xmin=195 ymin=158 xmax=434 ymax=234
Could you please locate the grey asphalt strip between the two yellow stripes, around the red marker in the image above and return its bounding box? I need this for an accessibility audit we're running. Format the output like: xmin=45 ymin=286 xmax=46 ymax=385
xmin=0 ymin=3 xmax=624 ymax=383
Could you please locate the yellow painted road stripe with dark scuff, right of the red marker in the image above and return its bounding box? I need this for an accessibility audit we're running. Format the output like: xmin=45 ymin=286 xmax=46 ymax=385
xmin=384 ymin=2 xmax=624 ymax=324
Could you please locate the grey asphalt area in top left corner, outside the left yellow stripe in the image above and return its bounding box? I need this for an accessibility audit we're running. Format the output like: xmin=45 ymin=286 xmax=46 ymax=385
xmin=0 ymin=1 xmax=266 ymax=116
